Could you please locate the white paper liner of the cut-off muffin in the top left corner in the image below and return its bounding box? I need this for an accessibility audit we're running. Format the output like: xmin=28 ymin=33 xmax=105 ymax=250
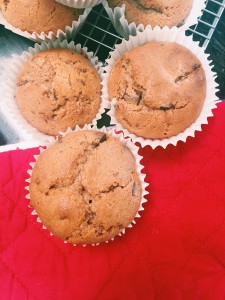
xmin=0 ymin=8 xmax=91 ymax=42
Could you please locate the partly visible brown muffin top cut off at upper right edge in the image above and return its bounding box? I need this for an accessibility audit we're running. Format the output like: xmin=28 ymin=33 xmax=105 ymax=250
xmin=108 ymin=0 xmax=193 ymax=27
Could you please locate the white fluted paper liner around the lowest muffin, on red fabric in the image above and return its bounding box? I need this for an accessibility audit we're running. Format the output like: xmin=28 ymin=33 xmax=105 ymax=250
xmin=25 ymin=125 xmax=149 ymax=246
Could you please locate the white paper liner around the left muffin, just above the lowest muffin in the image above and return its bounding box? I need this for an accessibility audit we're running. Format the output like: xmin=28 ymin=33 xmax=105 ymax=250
xmin=0 ymin=40 xmax=105 ymax=145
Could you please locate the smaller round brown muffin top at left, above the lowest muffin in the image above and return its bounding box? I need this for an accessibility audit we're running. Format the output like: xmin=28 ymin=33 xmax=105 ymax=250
xmin=16 ymin=49 xmax=101 ymax=135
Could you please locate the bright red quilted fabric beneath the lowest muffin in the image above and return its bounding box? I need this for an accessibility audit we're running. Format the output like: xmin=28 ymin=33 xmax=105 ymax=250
xmin=0 ymin=103 xmax=225 ymax=300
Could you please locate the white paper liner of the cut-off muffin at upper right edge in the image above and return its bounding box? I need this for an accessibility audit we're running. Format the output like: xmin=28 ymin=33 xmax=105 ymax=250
xmin=102 ymin=0 xmax=206 ymax=39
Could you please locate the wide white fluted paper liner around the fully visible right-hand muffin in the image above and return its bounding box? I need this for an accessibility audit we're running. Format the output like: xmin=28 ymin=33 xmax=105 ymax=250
xmin=102 ymin=26 xmax=218 ymax=149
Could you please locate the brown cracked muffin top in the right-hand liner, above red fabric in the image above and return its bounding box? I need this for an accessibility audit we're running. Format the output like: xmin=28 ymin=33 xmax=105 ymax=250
xmin=108 ymin=41 xmax=206 ymax=139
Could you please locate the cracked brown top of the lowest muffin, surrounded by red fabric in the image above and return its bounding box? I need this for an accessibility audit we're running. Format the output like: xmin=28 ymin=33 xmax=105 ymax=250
xmin=30 ymin=130 xmax=142 ymax=244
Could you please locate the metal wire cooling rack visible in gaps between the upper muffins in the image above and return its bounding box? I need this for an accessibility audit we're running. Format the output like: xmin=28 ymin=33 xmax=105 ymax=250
xmin=76 ymin=0 xmax=225 ymax=62
